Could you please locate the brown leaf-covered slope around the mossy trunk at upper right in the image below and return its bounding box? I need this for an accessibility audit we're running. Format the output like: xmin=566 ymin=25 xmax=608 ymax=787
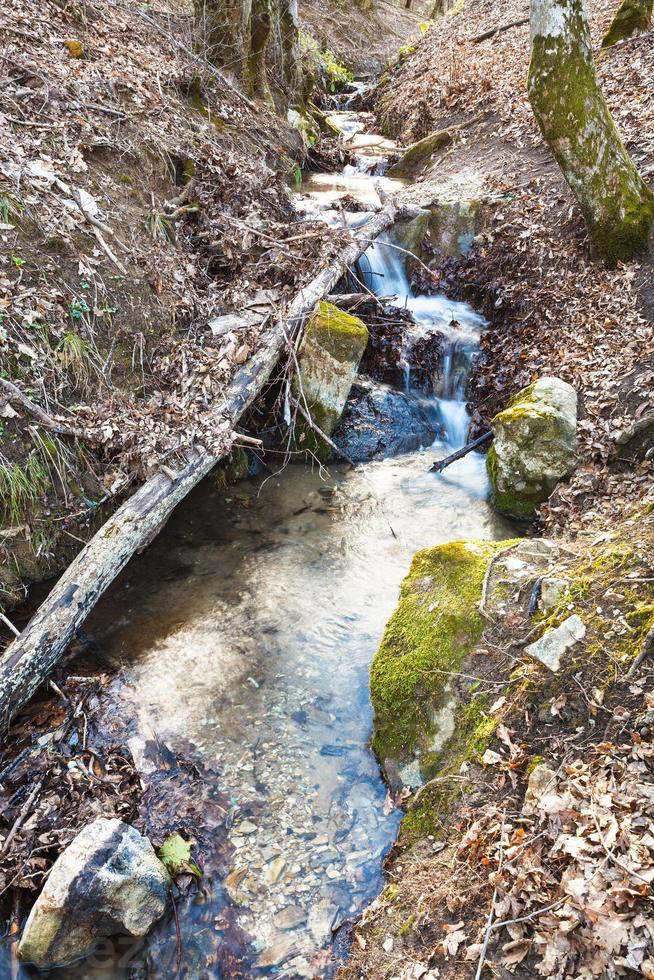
xmin=377 ymin=0 xmax=654 ymax=529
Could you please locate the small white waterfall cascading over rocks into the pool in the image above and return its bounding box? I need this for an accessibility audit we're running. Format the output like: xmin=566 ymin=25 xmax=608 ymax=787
xmin=361 ymin=234 xmax=486 ymax=449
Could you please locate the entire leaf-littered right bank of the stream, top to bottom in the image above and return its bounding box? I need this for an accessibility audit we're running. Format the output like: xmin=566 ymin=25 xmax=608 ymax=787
xmin=341 ymin=0 xmax=654 ymax=980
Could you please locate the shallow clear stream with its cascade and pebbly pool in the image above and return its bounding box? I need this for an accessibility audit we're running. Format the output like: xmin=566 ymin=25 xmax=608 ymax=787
xmin=9 ymin=88 xmax=508 ymax=980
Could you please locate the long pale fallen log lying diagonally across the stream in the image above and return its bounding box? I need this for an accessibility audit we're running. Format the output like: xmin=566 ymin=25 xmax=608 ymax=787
xmin=0 ymin=202 xmax=395 ymax=732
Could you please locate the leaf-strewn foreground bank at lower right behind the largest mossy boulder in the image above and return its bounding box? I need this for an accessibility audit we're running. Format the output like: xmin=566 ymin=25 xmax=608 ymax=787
xmin=340 ymin=501 xmax=654 ymax=980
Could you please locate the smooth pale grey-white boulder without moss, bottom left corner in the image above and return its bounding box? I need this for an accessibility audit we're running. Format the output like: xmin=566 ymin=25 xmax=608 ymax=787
xmin=18 ymin=818 xmax=171 ymax=970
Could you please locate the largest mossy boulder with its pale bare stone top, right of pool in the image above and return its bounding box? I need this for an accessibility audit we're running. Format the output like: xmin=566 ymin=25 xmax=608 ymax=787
xmin=370 ymin=538 xmax=564 ymax=789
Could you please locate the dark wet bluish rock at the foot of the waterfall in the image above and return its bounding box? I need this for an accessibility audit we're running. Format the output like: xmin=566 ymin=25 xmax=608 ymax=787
xmin=334 ymin=378 xmax=440 ymax=462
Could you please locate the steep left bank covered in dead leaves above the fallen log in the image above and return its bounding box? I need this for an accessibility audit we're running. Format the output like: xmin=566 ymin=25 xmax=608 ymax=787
xmin=0 ymin=0 xmax=364 ymax=608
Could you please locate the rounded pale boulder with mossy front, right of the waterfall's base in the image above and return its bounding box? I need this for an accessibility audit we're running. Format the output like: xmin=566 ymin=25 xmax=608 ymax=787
xmin=487 ymin=378 xmax=577 ymax=520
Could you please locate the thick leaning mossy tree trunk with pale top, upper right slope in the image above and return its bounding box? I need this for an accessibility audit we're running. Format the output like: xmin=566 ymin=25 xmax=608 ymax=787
xmin=528 ymin=0 xmax=654 ymax=265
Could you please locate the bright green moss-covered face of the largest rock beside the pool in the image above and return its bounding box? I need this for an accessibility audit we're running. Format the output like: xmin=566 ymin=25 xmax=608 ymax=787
xmin=370 ymin=541 xmax=507 ymax=786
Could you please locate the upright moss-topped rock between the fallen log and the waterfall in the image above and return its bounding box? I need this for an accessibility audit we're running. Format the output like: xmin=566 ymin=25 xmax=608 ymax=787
xmin=293 ymin=301 xmax=368 ymax=459
